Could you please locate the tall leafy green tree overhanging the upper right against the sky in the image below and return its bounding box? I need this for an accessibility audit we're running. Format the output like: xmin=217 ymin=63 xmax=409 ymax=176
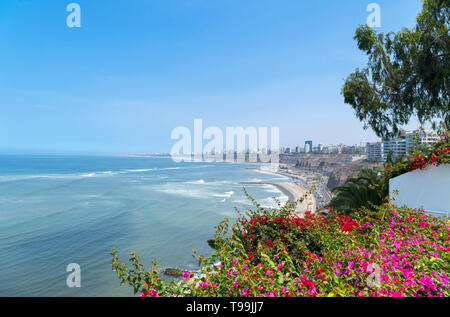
xmin=342 ymin=0 xmax=450 ymax=138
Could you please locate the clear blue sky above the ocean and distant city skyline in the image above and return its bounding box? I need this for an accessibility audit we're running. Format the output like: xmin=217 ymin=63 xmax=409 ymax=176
xmin=0 ymin=0 xmax=421 ymax=154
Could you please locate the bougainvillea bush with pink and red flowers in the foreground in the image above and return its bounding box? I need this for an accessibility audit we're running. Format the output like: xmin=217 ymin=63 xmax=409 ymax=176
xmin=112 ymin=190 xmax=450 ymax=297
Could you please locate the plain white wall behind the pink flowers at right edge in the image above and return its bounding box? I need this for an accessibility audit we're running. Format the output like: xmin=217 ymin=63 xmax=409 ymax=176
xmin=389 ymin=164 xmax=450 ymax=213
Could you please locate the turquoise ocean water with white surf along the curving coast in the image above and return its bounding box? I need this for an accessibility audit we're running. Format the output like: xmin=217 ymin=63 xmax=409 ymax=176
xmin=0 ymin=156 xmax=286 ymax=296
